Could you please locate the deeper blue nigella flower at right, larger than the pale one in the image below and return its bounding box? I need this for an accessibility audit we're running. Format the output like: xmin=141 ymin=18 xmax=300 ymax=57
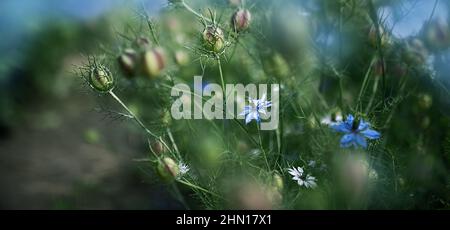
xmin=331 ymin=115 xmax=381 ymax=148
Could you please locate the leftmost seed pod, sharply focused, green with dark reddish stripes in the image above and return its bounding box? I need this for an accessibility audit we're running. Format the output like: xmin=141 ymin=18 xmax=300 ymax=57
xmin=88 ymin=64 xmax=114 ymax=93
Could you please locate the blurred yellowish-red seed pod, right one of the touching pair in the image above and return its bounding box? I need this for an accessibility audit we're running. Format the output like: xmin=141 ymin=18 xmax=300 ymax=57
xmin=142 ymin=47 xmax=166 ymax=78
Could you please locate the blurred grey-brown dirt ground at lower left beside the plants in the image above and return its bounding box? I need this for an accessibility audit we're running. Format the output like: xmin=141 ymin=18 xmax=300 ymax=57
xmin=0 ymin=92 xmax=180 ymax=209
